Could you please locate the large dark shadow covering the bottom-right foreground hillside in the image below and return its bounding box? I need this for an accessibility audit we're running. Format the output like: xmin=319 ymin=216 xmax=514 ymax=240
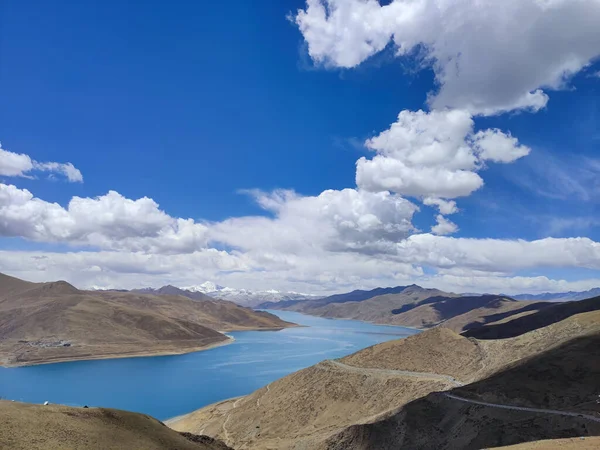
xmin=326 ymin=335 xmax=600 ymax=450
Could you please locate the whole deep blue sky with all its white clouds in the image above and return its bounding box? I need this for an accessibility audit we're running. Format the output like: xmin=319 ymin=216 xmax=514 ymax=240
xmin=0 ymin=0 xmax=600 ymax=294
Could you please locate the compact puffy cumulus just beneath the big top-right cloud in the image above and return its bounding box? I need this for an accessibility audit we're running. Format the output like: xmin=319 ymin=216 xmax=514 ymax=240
xmin=356 ymin=109 xmax=529 ymax=199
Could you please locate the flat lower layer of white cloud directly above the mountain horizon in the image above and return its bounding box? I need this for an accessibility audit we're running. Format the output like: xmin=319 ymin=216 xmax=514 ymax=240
xmin=0 ymin=244 xmax=600 ymax=294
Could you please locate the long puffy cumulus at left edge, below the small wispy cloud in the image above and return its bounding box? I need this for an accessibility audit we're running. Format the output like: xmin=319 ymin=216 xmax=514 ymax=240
xmin=0 ymin=184 xmax=206 ymax=252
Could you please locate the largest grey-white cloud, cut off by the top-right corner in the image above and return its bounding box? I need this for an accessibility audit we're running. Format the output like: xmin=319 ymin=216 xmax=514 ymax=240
xmin=295 ymin=0 xmax=600 ymax=115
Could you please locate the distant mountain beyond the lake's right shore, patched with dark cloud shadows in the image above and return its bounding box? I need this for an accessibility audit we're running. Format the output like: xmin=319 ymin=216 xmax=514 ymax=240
xmin=259 ymin=285 xmax=551 ymax=331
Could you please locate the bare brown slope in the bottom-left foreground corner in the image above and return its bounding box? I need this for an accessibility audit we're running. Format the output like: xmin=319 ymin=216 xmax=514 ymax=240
xmin=0 ymin=401 xmax=232 ymax=450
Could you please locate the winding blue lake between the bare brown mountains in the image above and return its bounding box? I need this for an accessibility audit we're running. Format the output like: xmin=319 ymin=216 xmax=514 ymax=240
xmin=0 ymin=311 xmax=418 ymax=420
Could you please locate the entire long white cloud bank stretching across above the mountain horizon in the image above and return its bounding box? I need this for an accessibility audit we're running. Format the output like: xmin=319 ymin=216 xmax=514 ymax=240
xmin=0 ymin=180 xmax=600 ymax=292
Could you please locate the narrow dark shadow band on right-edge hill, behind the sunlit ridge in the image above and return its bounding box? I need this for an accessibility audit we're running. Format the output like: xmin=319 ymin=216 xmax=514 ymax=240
xmin=463 ymin=297 xmax=600 ymax=339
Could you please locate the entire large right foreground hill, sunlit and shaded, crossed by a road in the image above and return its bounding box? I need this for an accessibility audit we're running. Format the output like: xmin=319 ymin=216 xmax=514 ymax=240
xmin=169 ymin=299 xmax=600 ymax=450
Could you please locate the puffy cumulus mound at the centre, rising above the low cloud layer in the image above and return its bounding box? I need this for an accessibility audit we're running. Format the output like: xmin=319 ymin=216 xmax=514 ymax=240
xmin=209 ymin=189 xmax=418 ymax=254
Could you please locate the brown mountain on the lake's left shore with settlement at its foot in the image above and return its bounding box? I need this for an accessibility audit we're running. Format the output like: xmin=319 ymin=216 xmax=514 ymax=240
xmin=0 ymin=274 xmax=293 ymax=366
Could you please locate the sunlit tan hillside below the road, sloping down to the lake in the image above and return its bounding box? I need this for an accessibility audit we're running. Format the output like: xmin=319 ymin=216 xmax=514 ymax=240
xmin=169 ymin=361 xmax=451 ymax=450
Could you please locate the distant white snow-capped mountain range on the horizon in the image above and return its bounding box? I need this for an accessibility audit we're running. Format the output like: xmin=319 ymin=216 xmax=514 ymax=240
xmin=182 ymin=281 xmax=319 ymax=306
